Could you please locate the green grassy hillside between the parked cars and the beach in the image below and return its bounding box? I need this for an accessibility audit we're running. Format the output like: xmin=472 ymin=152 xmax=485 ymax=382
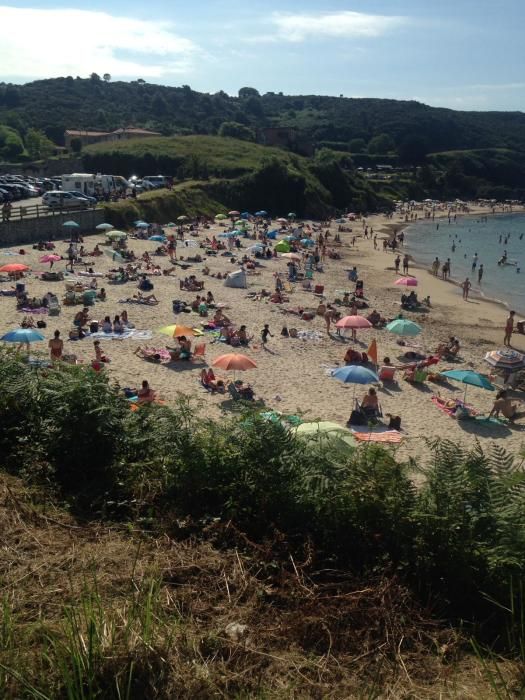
xmin=88 ymin=136 xmax=390 ymax=224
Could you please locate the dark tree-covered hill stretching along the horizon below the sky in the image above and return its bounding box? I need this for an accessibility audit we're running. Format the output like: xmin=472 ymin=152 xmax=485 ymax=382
xmin=0 ymin=74 xmax=525 ymax=160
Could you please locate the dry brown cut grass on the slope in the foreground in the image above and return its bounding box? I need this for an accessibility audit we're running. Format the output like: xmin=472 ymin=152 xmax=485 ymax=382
xmin=0 ymin=476 xmax=514 ymax=699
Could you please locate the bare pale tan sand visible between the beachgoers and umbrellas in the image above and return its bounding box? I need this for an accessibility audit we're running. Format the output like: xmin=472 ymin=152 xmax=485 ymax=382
xmin=0 ymin=204 xmax=525 ymax=459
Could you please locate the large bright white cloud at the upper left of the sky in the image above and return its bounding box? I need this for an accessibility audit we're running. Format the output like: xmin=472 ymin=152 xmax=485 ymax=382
xmin=0 ymin=6 xmax=200 ymax=79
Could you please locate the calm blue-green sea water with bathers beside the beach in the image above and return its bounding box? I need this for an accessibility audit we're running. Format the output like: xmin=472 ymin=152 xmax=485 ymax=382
xmin=405 ymin=214 xmax=525 ymax=314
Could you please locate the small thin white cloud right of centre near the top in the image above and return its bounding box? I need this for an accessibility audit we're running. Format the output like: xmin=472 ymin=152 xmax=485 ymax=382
xmin=271 ymin=11 xmax=408 ymax=42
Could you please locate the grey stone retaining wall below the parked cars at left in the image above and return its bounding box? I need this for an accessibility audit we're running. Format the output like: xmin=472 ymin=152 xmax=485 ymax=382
xmin=0 ymin=209 xmax=104 ymax=247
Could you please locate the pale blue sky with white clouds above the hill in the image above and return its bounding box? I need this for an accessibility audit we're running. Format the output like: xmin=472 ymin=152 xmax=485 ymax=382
xmin=0 ymin=0 xmax=525 ymax=111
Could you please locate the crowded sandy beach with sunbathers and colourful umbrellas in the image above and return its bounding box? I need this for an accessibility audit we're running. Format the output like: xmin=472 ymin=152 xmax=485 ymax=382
xmin=0 ymin=202 xmax=525 ymax=454
